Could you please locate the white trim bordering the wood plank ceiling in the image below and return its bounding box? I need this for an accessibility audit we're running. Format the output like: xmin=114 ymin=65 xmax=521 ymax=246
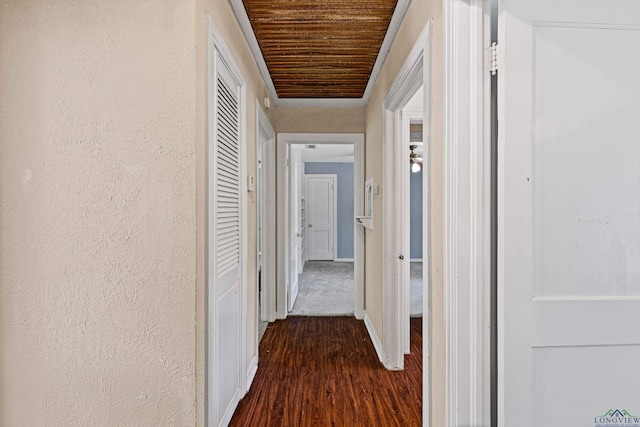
xmin=229 ymin=0 xmax=411 ymax=107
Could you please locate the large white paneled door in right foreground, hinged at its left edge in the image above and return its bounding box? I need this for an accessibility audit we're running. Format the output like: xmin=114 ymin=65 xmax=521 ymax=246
xmin=498 ymin=0 xmax=640 ymax=427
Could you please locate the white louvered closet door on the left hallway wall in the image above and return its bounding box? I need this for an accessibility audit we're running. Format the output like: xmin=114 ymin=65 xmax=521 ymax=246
xmin=209 ymin=57 xmax=242 ymax=425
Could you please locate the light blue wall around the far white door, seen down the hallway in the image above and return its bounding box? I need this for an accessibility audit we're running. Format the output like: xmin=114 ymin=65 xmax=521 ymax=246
xmin=304 ymin=162 xmax=354 ymax=258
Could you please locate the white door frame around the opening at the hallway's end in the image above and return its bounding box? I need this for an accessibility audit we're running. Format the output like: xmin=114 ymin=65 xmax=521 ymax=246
xmin=276 ymin=133 xmax=364 ymax=319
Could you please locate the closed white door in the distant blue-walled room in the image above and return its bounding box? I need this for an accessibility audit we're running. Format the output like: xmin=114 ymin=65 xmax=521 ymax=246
xmin=306 ymin=175 xmax=336 ymax=261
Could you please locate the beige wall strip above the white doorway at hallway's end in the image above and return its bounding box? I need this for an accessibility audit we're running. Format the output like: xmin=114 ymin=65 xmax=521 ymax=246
xmin=276 ymin=107 xmax=366 ymax=133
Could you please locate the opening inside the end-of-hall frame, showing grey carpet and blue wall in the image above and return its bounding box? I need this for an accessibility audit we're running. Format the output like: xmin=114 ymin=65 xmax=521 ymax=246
xmin=287 ymin=144 xmax=356 ymax=316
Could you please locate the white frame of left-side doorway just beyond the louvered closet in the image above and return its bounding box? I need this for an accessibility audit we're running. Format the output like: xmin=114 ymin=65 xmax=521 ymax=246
xmin=255 ymin=100 xmax=276 ymax=328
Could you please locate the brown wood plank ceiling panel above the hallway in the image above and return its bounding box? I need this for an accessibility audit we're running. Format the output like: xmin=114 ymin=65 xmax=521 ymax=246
xmin=243 ymin=0 xmax=397 ymax=98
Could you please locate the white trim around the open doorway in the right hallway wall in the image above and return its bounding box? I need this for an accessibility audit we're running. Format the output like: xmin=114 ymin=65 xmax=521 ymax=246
xmin=382 ymin=20 xmax=433 ymax=426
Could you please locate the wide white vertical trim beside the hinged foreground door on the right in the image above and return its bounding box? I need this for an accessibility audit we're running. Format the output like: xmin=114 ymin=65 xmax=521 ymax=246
xmin=443 ymin=0 xmax=491 ymax=427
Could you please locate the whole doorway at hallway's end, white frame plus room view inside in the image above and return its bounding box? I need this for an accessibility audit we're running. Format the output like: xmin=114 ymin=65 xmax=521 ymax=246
xmin=276 ymin=133 xmax=364 ymax=319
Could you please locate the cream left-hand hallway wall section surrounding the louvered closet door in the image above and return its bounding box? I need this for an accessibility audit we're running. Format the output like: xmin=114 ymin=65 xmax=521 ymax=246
xmin=195 ymin=0 xmax=275 ymax=426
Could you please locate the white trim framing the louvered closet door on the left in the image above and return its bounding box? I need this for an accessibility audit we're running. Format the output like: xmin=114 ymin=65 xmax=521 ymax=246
xmin=205 ymin=15 xmax=246 ymax=425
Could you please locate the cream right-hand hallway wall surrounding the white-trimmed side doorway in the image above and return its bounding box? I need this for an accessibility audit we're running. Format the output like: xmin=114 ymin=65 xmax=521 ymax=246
xmin=365 ymin=0 xmax=445 ymax=427
